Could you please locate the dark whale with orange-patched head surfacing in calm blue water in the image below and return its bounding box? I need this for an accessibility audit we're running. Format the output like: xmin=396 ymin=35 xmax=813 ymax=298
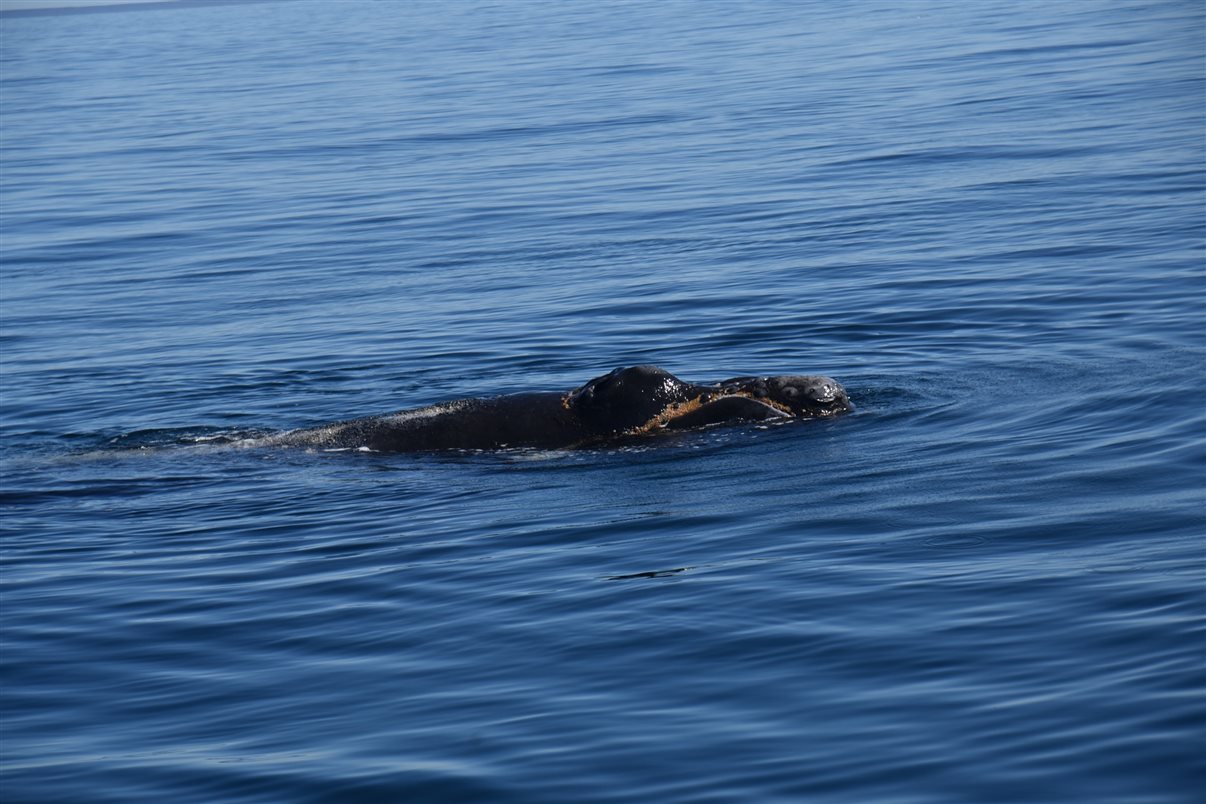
xmin=260 ymin=365 xmax=851 ymax=452
